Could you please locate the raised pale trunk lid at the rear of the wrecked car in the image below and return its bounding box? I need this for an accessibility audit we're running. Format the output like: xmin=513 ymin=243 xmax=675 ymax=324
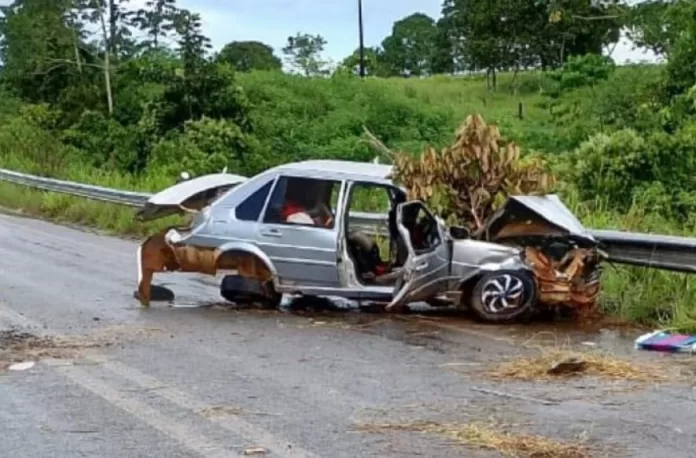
xmin=136 ymin=173 xmax=247 ymax=221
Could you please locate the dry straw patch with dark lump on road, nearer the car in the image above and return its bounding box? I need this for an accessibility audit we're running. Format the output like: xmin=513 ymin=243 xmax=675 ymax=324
xmin=486 ymin=349 xmax=666 ymax=382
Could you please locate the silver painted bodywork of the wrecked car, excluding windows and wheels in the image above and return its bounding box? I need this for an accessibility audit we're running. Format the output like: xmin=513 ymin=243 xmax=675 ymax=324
xmin=144 ymin=160 xmax=528 ymax=307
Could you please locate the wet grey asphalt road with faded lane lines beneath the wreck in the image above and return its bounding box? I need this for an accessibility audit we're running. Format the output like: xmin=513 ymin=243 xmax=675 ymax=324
xmin=0 ymin=215 xmax=696 ymax=458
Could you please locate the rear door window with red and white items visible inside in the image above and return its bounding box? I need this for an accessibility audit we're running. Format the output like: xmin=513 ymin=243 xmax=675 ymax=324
xmin=263 ymin=177 xmax=341 ymax=229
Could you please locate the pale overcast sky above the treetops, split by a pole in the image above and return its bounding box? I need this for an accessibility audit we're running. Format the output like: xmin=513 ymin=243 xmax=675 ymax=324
xmin=0 ymin=0 xmax=654 ymax=63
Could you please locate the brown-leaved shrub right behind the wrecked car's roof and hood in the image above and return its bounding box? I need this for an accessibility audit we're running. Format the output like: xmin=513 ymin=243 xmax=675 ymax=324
xmin=364 ymin=115 xmax=555 ymax=232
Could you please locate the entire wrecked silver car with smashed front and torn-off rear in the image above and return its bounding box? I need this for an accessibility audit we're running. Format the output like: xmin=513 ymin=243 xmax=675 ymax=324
xmin=138 ymin=160 xmax=600 ymax=321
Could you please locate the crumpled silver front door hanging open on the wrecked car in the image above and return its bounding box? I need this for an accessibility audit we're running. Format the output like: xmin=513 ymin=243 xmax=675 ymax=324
xmin=386 ymin=201 xmax=452 ymax=311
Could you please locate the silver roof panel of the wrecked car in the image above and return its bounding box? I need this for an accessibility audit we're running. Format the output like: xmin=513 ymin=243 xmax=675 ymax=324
xmin=273 ymin=159 xmax=393 ymax=184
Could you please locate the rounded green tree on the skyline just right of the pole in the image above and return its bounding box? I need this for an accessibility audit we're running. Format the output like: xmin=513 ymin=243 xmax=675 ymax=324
xmin=382 ymin=13 xmax=438 ymax=76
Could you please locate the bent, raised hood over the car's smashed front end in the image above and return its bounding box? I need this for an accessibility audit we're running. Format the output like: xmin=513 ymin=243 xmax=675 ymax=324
xmin=480 ymin=194 xmax=596 ymax=242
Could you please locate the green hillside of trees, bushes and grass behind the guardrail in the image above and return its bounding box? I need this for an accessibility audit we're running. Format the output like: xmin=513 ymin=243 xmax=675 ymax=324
xmin=0 ymin=0 xmax=696 ymax=329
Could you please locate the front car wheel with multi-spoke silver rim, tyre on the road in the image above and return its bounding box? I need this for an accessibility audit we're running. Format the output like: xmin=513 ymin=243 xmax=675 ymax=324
xmin=471 ymin=270 xmax=537 ymax=323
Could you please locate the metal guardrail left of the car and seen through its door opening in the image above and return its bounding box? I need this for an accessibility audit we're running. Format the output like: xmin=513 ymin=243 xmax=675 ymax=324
xmin=0 ymin=169 xmax=387 ymax=233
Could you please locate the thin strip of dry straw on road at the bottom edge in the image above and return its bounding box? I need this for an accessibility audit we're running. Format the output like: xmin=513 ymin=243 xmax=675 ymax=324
xmin=357 ymin=422 xmax=591 ymax=458
